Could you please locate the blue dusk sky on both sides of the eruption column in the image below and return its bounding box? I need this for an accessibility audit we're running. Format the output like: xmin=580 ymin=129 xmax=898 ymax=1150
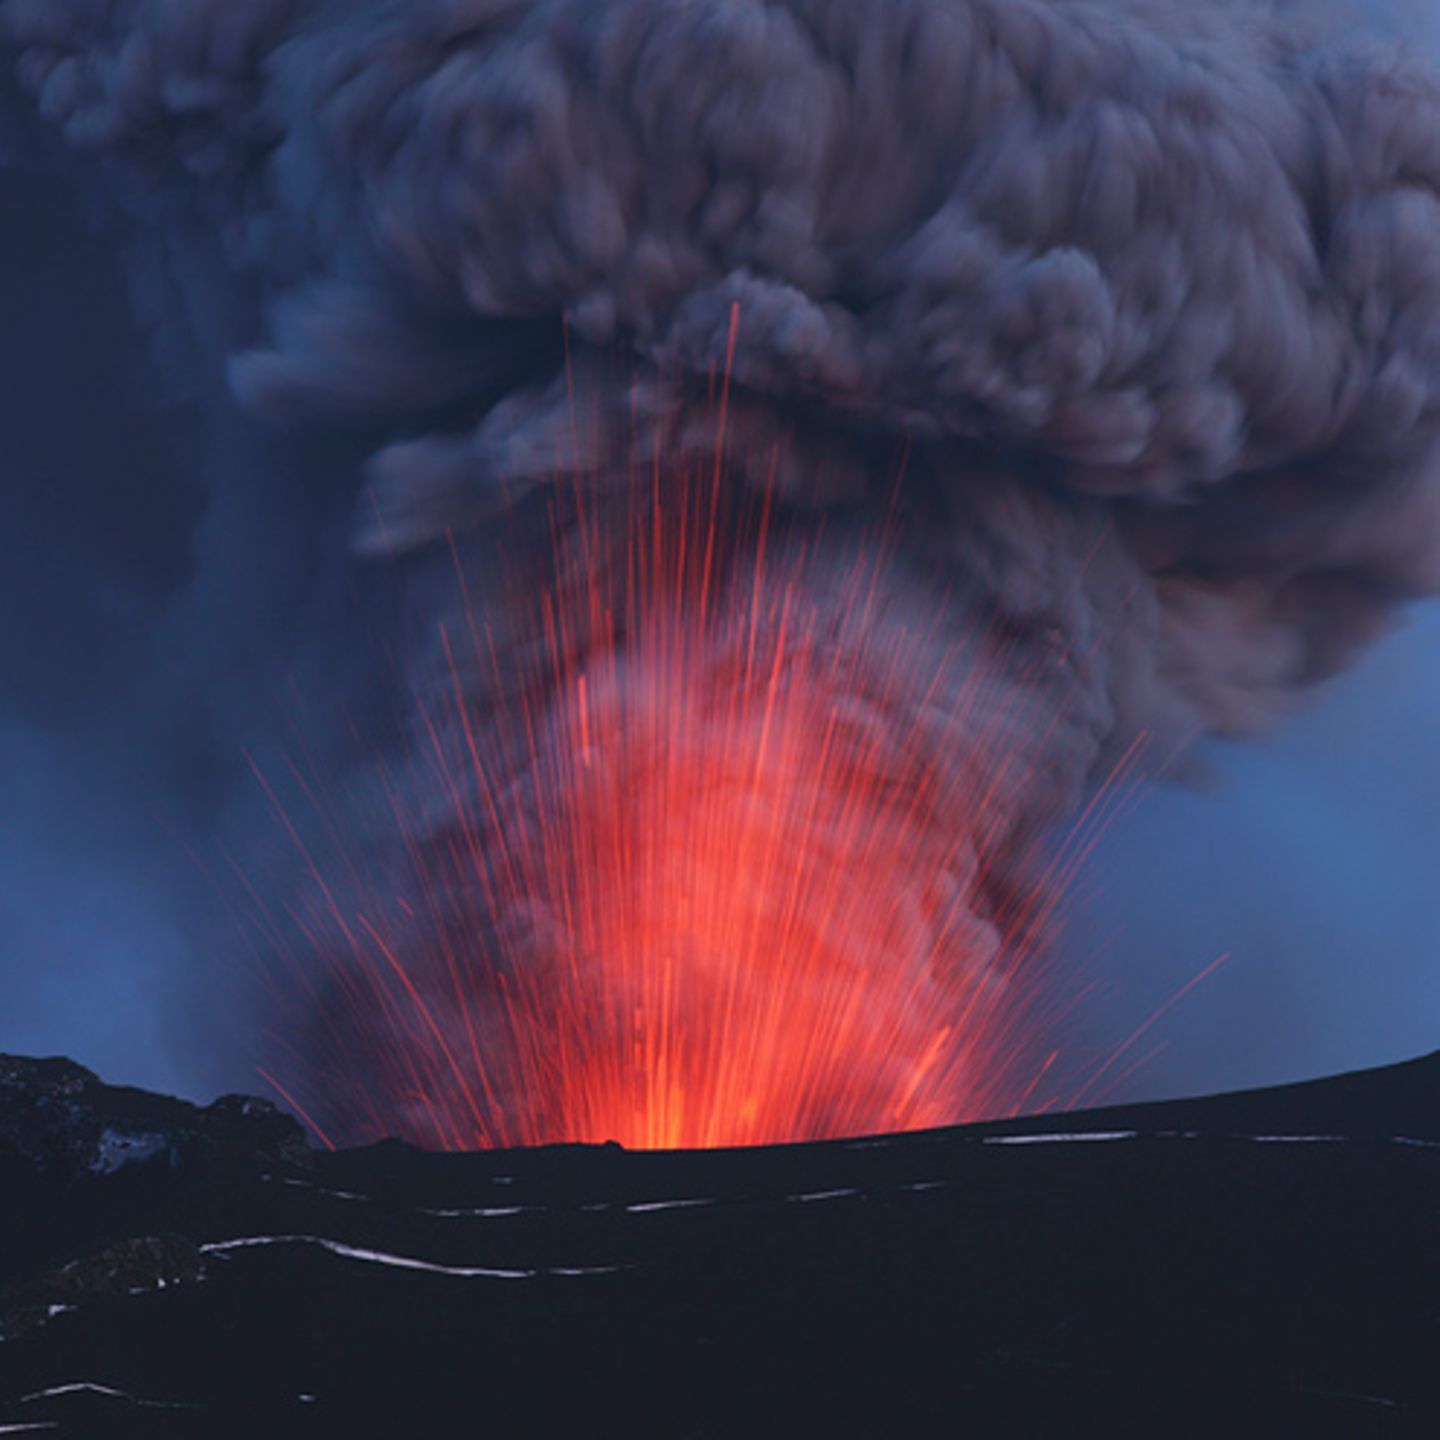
xmin=0 ymin=0 xmax=1440 ymax=1134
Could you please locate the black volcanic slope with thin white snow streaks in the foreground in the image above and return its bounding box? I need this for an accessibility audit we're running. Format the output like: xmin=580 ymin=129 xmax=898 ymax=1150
xmin=0 ymin=1056 xmax=1440 ymax=1440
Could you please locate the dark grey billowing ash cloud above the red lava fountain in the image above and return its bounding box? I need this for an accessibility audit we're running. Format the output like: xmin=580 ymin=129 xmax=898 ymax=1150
xmin=0 ymin=0 xmax=1440 ymax=1134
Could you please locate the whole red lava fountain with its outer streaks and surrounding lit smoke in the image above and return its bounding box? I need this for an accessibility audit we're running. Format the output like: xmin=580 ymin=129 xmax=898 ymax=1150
xmin=244 ymin=324 xmax=1123 ymax=1148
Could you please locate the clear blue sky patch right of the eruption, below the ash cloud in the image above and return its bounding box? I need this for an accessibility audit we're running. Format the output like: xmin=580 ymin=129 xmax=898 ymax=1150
xmin=1068 ymin=603 xmax=1440 ymax=1094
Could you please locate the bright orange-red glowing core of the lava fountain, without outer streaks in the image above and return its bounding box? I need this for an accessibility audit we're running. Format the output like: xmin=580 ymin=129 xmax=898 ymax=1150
xmin=443 ymin=506 xmax=1031 ymax=1148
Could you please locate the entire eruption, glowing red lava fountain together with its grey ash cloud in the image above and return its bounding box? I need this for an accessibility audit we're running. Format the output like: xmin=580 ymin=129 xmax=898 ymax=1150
xmin=0 ymin=0 xmax=1440 ymax=1148
